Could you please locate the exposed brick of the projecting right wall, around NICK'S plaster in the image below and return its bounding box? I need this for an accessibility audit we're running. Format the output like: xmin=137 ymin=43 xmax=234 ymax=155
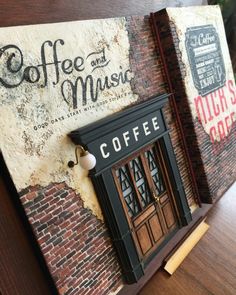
xmin=155 ymin=10 xmax=236 ymax=203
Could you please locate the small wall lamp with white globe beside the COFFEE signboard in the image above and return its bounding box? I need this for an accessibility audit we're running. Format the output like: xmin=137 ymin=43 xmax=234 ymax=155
xmin=68 ymin=145 xmax=96 ymax=170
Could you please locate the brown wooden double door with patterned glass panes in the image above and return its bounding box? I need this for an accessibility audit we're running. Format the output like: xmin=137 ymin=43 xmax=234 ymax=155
xmin=113 ymin=142 xmax=178 ymax=259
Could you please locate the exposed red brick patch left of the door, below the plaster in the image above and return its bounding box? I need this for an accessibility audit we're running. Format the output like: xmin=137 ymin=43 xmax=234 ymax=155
xmin=21 ymin=183 xmax=121 ymax=295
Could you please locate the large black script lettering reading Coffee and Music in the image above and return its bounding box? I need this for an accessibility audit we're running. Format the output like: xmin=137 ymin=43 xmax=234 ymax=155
xmin=0 ymin=39 xmax=132 ymax=109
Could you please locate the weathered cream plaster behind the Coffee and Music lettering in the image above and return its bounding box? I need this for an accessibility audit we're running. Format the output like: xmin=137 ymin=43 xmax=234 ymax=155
xmin=0 ymin=18 xmax=138 ymax=218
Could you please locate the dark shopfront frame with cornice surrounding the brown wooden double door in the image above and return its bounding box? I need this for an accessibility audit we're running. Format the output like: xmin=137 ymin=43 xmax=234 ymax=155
xmin=68 ymin=94 xmax=192 ymax=284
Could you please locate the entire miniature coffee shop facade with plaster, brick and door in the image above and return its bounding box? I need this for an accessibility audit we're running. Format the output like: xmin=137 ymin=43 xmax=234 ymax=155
xmin=0 ymin=6 xmax=236 ymax=295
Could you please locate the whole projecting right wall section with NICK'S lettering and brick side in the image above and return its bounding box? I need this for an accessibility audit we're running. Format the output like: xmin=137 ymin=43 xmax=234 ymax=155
xmin=156 ymin=6 xmax=236 ymax=203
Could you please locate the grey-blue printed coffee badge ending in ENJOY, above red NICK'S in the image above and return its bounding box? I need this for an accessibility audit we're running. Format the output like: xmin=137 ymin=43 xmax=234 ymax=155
xmin=185 ymin=25 xmax=226 ymax=96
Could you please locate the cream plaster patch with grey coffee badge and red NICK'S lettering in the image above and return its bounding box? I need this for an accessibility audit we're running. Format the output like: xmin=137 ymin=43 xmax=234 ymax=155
xmin=167 ymin=5 xmax=236 ymax=146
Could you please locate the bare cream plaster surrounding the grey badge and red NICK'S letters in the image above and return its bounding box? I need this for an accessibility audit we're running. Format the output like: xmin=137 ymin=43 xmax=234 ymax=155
xmin=167 ymin=6 xmax=236 ymax=141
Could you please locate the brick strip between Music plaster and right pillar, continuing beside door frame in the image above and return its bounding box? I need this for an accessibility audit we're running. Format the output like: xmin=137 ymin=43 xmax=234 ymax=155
xmin=127 ymin=16 xmax=195 ymax=206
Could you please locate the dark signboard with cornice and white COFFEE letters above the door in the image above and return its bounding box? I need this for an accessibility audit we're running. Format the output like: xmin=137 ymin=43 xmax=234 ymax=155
xmin=69 ymin=95 xmax=168 ymax=173
